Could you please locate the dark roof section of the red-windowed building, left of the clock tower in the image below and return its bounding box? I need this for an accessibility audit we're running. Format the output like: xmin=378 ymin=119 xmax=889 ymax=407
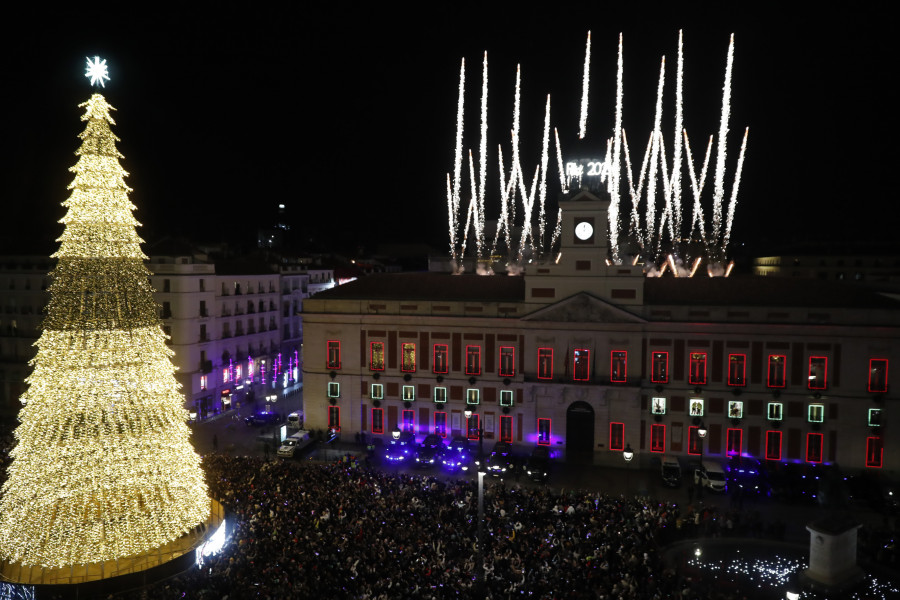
xmin=316 ymin=273 xmax=525 ymax=302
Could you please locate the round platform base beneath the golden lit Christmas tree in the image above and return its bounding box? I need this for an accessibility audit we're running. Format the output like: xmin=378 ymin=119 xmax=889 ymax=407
xmin=0 ymin=500 xmax=225 ymax=599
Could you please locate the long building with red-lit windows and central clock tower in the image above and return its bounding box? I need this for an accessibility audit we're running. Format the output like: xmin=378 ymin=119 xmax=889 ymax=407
xmin=304 ymin=192 xmax=900 ymax=469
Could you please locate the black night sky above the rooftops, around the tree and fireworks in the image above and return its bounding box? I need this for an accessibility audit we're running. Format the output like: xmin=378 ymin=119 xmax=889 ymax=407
xmin=0 ymin=2 xmax=900 ymax=253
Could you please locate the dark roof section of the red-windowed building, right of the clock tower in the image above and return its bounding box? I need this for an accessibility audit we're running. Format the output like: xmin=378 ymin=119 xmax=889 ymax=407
xmin=644 ymin=276 xmax=900 ymax=310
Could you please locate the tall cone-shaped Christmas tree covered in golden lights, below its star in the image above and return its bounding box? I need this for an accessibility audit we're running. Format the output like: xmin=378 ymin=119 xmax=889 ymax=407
xmin=0 ymin=69 xmax=210 ymax=568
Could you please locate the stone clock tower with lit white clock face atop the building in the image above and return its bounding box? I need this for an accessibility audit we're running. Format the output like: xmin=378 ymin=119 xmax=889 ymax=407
xmin=525 ymin=190 xmax=644 ymax=304
